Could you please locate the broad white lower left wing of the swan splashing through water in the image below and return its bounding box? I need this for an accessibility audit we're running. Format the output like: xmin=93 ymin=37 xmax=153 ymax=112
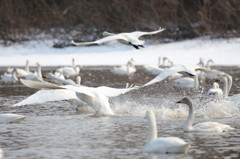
xmin=13 ymin=89 xmax=78 ymax=107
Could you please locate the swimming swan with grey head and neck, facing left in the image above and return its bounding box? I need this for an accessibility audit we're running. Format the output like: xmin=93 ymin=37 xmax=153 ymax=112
xmin=177 ymin=97 xmax=234 ymax=132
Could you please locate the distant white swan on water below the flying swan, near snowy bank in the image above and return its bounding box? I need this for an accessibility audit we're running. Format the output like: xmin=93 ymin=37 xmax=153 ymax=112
xmin=111 ymin=58 xmax=137 ymax=75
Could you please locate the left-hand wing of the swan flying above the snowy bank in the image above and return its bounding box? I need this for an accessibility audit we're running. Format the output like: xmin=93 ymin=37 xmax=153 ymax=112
xmin=71 ymin=34 xmax=128 ymax=46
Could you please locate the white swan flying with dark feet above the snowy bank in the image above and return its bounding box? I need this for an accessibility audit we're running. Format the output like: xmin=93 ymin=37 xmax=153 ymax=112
xmin=71 ymin=27 xmax=165 ymax=49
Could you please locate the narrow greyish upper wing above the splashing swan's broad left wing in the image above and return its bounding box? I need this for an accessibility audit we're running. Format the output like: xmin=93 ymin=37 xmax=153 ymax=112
xmin=20 ymin=79 xmax=62 ymax=89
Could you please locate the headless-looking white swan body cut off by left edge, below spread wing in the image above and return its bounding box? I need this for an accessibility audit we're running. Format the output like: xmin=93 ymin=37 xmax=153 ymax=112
xmin=0 ymin=113 xmax=26 ymax=123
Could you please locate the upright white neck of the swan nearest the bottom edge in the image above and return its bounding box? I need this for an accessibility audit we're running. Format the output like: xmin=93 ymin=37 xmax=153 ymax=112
xmin=147 ymin=112 xmax=157 ymax=145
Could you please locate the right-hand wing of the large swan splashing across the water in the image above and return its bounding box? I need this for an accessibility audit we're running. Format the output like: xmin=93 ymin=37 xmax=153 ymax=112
xmin=96 ymin=86 xmax=139 ymax=97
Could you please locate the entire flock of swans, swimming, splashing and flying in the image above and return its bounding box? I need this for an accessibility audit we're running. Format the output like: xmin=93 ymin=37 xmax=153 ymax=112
xmin=0 ymin=28 xmax=239 ymax=156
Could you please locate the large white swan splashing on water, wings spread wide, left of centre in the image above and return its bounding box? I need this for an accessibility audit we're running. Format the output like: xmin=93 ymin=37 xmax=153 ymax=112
xmin=14 ymin=79 xmax=137 ymax=115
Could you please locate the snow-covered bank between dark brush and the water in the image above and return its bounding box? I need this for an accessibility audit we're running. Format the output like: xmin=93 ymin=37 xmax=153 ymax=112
xmin=0 ymin=38 xmax=240 ymax=66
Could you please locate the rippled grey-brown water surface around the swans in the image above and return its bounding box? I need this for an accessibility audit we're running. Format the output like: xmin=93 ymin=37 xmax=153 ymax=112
xmin=0 ymin=66 xmax=240 ymax=159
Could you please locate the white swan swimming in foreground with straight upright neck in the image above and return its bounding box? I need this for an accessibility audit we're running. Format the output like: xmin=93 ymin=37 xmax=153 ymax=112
xmin=144 ymin=110 xmax=190 ymax=154
